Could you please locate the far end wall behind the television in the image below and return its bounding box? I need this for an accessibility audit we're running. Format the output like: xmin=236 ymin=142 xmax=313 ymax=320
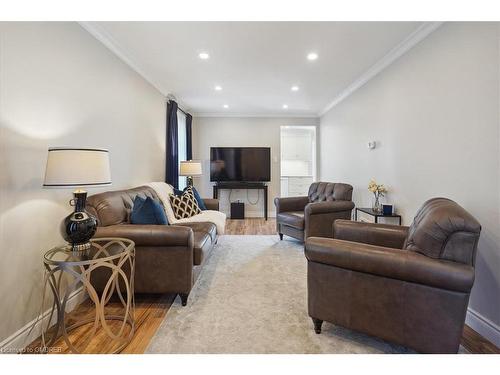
xmin=193 ymin=117 xmax=318 ymax=217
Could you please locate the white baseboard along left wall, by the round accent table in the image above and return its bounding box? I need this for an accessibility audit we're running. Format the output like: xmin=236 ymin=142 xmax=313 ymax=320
xmin=0 ymin=288 xmax=87 ymax=354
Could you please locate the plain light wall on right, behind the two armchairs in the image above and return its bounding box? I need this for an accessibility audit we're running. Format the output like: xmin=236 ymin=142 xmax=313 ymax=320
xmin=320 ymin=23 xmax=500 ymax=345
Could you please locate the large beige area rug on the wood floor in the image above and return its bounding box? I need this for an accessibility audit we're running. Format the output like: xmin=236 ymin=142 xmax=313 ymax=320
xmin=146 ymin=236 xmax=458 ymax=353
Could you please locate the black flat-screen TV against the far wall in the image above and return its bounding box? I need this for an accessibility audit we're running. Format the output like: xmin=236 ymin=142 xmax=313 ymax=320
xmin=210 ymin=147 xmax=271 ymax=182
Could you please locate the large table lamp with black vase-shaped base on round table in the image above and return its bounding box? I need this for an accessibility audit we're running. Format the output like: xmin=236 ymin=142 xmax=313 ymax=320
xmin=43 ymin=147 xmax=111 ymax=252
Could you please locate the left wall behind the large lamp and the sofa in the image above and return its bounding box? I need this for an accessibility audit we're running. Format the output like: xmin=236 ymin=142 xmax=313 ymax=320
xmin=0 ymin=22 xmax=165 ymax=342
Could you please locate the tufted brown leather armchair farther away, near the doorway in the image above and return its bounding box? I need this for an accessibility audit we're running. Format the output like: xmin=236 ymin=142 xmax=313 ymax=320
xmin=274 ymin=182 xmax=354 ymax=241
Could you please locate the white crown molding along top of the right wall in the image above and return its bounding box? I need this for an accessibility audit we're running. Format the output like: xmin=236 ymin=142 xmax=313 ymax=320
xmin=318 ymin=22 xmax=443 ymax=117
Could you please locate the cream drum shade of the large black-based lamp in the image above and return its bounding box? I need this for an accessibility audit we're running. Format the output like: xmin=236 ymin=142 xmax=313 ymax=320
xmin=43 ymin=147 xmax=111 ymax=188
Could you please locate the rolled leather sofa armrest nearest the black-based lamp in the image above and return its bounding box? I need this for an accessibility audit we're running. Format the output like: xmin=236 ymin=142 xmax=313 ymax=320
xmin=95 ymin=224 xmax=193 ymax=249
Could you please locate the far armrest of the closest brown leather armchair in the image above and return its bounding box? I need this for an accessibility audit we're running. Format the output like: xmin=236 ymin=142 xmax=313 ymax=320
xmin=333 ymin=220 xmax=408 ymax=249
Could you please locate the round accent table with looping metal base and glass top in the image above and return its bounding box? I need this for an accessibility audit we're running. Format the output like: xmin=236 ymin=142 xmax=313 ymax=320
xmin=42 ymin=238 xmax=135 ymax=353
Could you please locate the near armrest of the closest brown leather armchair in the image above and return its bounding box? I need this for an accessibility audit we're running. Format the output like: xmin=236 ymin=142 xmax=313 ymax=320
xmin=305 ymin=237 xmax=474 ymax=293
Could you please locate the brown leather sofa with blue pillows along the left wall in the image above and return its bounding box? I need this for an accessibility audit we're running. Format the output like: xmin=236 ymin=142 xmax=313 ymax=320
xmin=87 ymin=186 xmax=219 ymax=305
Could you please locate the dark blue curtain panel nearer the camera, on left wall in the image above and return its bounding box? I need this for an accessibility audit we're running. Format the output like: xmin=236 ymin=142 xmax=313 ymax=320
xmin=165 ymin=100 xmax=179 ymax=189
